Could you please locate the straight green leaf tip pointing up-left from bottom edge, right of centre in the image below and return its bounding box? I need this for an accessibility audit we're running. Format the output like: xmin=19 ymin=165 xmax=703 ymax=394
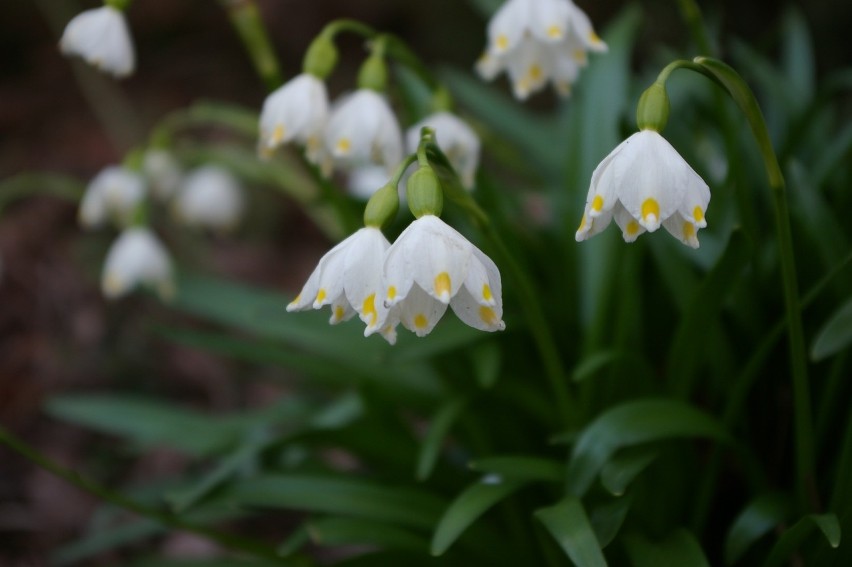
xmin=535 ymin=498 xmax=607 ymax=567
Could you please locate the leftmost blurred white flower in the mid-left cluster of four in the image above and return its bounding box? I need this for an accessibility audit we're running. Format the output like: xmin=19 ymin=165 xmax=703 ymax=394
xmin=79 ymin=165 xmax=147 ymax=228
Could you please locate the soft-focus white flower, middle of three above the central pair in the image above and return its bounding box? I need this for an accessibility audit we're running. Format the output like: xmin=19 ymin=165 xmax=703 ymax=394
xmin=325 ymin=89 xmax=402 ymax=174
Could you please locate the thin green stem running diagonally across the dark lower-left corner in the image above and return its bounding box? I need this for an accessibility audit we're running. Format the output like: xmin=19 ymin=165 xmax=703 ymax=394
xmin=0 ymin=427 xmax=290 ymax=563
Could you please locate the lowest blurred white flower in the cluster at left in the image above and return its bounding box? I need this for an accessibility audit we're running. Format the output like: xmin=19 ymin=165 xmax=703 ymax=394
xmin=101 ymin=227 xmax=174 ymax=299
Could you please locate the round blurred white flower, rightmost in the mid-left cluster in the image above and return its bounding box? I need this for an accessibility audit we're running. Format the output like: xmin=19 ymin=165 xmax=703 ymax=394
xmin=172 ymin=165 xmax=244 ymax=230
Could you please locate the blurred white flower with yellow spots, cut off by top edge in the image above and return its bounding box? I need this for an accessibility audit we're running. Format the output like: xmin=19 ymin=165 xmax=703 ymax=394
xmin=476 ymin=0 xmax=607 ymax=100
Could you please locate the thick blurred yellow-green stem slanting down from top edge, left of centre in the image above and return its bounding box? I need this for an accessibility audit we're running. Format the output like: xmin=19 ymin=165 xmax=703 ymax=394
xmin=219 ymin=0 xmax=283 ymax=90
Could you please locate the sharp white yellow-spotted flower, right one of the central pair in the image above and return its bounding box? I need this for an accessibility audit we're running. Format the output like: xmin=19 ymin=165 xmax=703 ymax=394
xmin=384 ymin=215 xmax=506 ymax=337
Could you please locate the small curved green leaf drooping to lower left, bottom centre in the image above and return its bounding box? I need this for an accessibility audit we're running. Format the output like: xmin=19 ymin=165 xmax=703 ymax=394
xmin=431 ymin=476 xmax=526 ymax=556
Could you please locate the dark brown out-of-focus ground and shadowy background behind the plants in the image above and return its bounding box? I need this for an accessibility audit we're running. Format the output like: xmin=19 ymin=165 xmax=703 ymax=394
xmin=0 ymin=0 xmax=852 ymax=565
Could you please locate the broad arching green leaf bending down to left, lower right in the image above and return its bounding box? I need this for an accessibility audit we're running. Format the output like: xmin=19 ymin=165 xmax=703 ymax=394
xmin=567 ymin=399 xmax=729 ymax=496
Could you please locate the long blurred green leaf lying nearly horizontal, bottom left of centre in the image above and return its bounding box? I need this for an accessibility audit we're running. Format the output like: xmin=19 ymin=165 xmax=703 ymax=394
xmin=221 ymin=474 xmax=444 ymax=528
